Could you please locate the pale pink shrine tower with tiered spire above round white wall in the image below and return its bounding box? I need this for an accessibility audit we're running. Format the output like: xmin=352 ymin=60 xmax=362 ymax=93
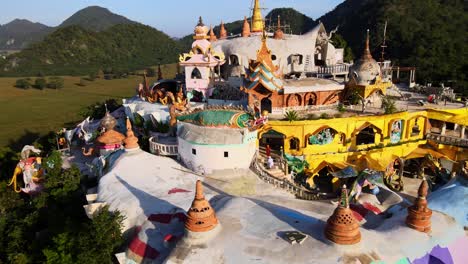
xmin=179 ymin=17 xmax=225 ymax=100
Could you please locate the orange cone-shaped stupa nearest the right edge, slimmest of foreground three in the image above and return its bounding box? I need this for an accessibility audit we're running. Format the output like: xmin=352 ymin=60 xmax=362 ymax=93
xmin=406 ymin=179 xmax=432 ymax=233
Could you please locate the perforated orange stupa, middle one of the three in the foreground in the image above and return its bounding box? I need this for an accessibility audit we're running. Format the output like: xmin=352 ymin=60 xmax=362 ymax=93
xmin=325 ymin=185 xmax=361 ymax=245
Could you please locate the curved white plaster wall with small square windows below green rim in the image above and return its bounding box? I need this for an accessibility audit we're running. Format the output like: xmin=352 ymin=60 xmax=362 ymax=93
xmin=178 ymin=135 xmax=257 ymax=174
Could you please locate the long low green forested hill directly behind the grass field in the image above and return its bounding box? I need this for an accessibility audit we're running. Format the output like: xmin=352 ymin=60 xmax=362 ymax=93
xmin=0 ymin=24 xmax=181 ymax=76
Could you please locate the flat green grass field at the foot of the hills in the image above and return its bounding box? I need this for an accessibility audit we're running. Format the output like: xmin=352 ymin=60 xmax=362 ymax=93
xmin=0 ymin=76 xmax=165 ymax=147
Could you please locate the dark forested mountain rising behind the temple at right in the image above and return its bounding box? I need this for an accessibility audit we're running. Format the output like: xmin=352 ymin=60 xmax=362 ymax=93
xmin=318 ymin=0 xmax=468 ymax=93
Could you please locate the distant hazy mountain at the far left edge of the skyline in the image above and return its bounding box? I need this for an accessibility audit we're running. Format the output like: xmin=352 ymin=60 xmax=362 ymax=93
xmin=0 ymin=19 xmax=53 ymax=50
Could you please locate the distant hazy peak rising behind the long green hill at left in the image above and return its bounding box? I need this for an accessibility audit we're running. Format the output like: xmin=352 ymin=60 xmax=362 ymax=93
xmin=59 ymin=6 xmax=136 ymax=31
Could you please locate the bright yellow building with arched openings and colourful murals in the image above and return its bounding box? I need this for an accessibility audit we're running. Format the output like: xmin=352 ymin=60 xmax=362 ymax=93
xmin=258 ymin=108 xmax=468 ymax=190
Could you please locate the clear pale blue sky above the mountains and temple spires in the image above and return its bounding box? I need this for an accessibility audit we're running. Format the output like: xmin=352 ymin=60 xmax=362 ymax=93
xmin=0 ymin=0 xmax=343 ymax=37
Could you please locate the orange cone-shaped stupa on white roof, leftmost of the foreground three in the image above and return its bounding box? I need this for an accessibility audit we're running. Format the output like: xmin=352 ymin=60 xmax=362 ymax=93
xmin=185 ymin=180 xmax=218 ymax=232
